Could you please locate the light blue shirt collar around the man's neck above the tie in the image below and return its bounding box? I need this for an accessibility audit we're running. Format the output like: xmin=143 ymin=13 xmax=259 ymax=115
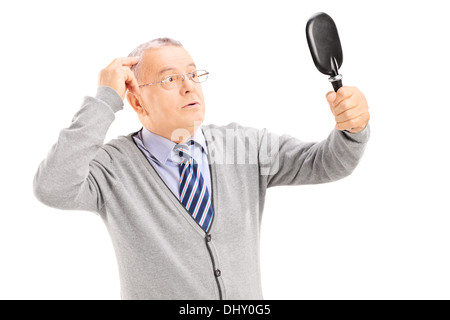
xmin=142 ymin=127 xmax=208 ymax=164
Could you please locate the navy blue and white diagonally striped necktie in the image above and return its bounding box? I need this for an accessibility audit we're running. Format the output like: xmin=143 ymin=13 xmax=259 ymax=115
xmin=174 ymin=140 xmax=213 ymax=232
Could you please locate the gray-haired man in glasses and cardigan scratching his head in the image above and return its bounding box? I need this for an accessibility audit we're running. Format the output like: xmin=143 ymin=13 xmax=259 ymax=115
xmin=34 ymin=38 xmax=369 ymax=299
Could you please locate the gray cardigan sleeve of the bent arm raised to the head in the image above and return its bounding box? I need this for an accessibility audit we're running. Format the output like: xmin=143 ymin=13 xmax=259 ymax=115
xmin=33 ymin=86 xmax=123 ymax=212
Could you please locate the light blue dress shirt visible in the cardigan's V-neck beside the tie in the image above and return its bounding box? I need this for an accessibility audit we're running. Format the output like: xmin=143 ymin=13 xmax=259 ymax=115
xmin=133 ymin=127 xmax=211 ymax=199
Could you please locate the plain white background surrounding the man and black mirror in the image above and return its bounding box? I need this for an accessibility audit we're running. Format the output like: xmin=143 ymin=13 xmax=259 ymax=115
xmin=0 ymin=0 xmax=450 ymax=299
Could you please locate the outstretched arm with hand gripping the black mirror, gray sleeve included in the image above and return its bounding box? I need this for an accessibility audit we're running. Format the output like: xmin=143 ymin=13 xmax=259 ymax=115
xmin=259 ymin=87 xmax=370 ymax=188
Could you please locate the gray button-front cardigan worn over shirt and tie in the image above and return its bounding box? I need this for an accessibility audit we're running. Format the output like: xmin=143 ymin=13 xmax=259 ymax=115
xmin=33 ymin=87 xmax=369 ymax=299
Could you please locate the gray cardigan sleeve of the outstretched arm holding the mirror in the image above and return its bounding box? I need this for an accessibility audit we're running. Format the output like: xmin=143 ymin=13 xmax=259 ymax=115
xmin=258 ymin=124 xmax=370 ymax=188
